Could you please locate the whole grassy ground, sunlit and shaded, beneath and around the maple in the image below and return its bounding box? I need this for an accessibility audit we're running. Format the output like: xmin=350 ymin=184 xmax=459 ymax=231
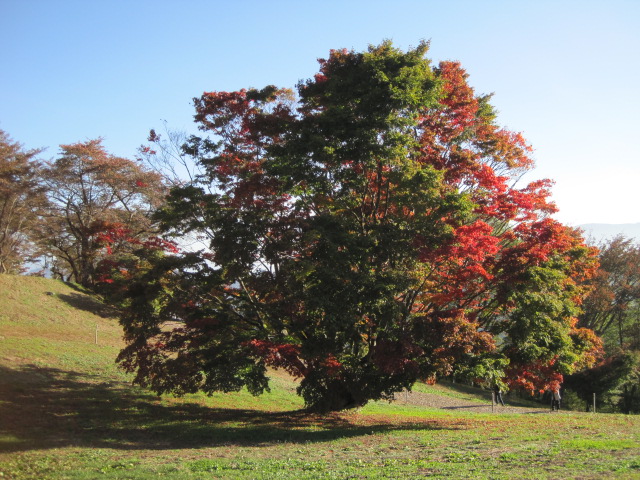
xmin=0 ymin=275 xmax=640 ymax=479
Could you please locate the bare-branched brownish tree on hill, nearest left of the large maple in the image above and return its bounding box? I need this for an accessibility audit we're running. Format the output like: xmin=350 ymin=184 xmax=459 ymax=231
xmin=36 ymin=139 xmax=166 ymax=287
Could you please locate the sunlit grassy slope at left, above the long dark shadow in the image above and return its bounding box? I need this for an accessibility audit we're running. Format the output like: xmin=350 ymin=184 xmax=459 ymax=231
xmin=0 ymin=275 xmax=122 ymax=375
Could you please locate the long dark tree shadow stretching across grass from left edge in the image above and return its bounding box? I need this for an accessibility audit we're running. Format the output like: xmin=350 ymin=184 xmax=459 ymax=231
xmin=0 ymin=365 xmax=462 ymax=452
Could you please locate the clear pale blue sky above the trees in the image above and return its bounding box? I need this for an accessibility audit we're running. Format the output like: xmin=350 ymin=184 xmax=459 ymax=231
xmin=0 ymin=0 xmax=640 ymax=225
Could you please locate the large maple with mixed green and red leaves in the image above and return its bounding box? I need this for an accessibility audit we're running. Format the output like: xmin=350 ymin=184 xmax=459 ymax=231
xmin=119 ymin=42 xmax=598 ymax=411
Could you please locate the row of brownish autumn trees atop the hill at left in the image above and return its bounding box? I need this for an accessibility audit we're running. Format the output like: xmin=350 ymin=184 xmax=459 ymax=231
xmin=0 ymin=131 xmax=167 ymax=288
